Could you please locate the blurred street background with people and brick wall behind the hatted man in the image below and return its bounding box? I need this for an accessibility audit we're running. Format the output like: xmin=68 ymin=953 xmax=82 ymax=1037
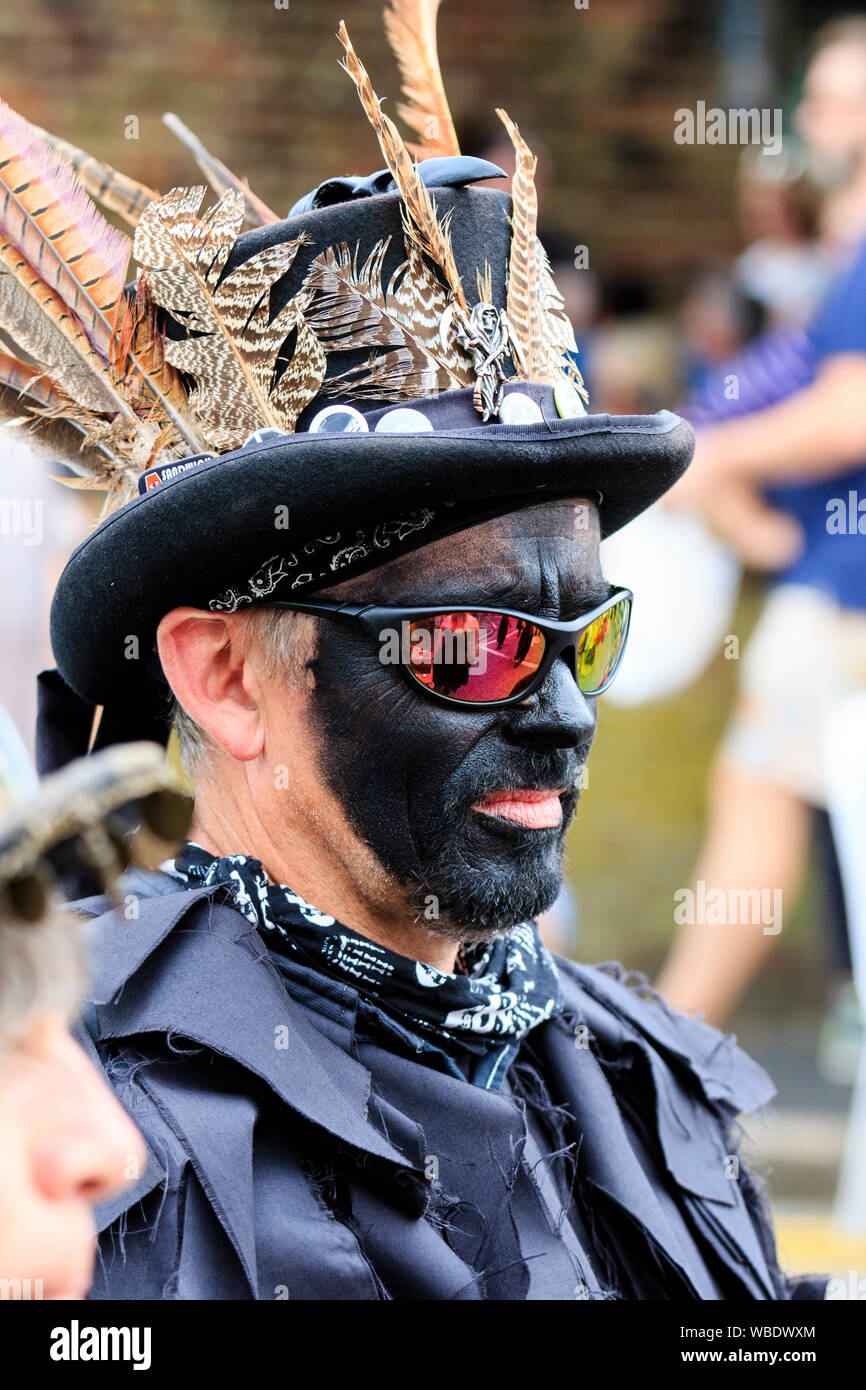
xmin=0 ymin=0 xmax=866 ymax=1276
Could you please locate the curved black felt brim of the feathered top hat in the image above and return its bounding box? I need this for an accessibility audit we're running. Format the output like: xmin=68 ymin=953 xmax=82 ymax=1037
xmin=51 ymin=411 xmax=694 ymax=705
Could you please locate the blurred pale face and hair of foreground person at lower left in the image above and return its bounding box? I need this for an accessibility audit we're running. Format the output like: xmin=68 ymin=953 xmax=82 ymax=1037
xmin=0 ymin=909 xmax=143 ymax=1298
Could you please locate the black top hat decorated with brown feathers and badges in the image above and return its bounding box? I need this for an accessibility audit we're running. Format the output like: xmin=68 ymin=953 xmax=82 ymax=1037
xmin=0 ymin=16 xmax=692 ymax=767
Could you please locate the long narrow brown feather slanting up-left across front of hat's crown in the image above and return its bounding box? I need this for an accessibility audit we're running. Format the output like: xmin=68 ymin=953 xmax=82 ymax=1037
xmin=338 ymin=21 xmax=467 ymax=311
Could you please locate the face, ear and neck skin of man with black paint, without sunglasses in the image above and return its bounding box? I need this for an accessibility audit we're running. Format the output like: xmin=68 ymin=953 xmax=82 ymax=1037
xmin=158 ymin=500 xmax=610 ymax=970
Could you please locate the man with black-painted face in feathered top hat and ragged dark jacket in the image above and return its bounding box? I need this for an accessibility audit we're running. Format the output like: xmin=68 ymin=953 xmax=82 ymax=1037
xmin=28 ymin=10 xmax=822 ymax=1301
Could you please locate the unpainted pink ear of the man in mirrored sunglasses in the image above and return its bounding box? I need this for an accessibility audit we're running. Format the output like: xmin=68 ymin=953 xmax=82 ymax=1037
xmin=157 ymin=607 xmax=264 ymax=762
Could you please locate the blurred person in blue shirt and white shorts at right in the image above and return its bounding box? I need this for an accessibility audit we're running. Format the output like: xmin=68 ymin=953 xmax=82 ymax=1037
xmin=659 ymin=18 xmax=866 ymax=1023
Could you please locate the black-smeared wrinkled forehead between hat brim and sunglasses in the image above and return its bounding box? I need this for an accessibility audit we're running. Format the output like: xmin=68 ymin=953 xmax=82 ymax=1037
xmin=326 ymin=498 xmax=601 ymax=602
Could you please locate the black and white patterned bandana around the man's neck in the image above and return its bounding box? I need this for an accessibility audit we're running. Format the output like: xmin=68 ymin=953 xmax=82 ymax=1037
xmin=165 ymin=844 xmax=562 ymax=1055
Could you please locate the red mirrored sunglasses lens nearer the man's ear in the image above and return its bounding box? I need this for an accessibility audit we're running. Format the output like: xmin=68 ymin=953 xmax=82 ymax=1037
xmin=409 ymin=612 xmax=545 ymax=703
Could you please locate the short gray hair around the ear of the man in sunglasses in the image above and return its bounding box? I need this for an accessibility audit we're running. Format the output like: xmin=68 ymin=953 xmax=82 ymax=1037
xmin=172 ymin=607 xmax=317 ymax=781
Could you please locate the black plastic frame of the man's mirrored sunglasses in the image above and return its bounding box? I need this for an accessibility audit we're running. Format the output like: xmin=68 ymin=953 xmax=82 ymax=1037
xmin=263 ymin=589 xmax=634 ymax=710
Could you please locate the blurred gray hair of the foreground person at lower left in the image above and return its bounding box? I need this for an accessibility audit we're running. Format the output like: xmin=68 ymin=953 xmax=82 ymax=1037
xmin=0 ymin=908 xmax=85 ymax=1056
